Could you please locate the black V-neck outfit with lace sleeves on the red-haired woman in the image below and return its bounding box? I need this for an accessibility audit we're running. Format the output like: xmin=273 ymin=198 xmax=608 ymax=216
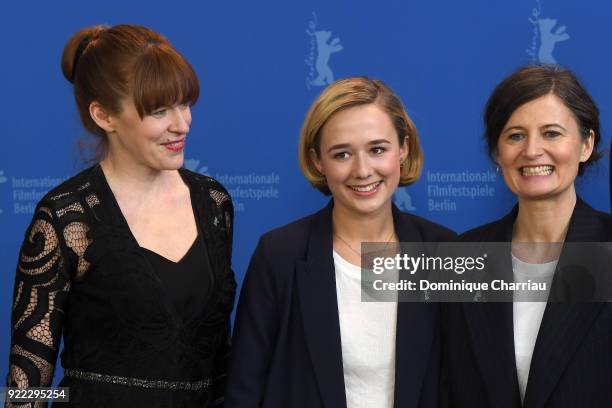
xmin=8 ymin=165 xmax=236 ymax=408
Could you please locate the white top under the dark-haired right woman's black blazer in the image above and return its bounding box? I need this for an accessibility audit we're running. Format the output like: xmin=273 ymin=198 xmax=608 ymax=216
xmin=512 ymin=255 xmax=557 ymax=401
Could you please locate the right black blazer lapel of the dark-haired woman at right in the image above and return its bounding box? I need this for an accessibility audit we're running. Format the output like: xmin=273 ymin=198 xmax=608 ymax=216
xmin=524 ymin=197 xmax=605 ymax=407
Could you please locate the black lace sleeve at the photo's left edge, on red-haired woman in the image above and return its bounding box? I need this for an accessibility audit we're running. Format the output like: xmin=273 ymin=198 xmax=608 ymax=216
xmin=7 ymin=205 xmax=70 ymax=407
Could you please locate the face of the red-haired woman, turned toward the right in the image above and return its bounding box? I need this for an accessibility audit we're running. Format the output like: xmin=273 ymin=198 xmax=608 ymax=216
xmin=109 ymin=99 xmax=191 ymax=170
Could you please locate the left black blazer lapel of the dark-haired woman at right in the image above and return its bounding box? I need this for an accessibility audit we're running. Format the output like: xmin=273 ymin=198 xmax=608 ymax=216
xmin=464 ymin=206 xmax=521 ymax=408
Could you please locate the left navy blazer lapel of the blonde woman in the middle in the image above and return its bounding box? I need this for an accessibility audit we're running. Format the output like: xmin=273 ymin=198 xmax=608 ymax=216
xmin=296 ymin=202 xmax=346 ymax=408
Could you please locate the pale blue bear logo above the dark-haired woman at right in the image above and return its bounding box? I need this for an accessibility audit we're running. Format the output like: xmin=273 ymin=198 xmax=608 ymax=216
xmin=527 ymin=0 xmax=570 ymax=64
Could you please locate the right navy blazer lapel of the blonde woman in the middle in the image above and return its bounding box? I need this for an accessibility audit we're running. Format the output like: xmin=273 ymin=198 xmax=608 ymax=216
xmin=393 ymin=205 xmax=439 ymax=408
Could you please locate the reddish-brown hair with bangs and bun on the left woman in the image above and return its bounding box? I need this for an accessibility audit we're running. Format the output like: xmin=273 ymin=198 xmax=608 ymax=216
xmin=62 ymin=24 xmax=200 ymax=155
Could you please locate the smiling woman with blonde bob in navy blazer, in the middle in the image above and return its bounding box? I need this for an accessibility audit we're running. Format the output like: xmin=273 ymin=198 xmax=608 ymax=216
xmin=225 ymin=77 xmax=454 ymax=408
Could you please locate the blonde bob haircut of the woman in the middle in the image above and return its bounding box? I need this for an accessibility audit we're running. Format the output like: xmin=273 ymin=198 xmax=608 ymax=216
xmin=298 ymin=76 xmax=423 ymax=195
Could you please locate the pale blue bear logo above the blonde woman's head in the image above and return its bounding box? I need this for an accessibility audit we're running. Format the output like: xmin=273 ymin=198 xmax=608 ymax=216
xmin=304 ymin=12 xmax=343 ymax=89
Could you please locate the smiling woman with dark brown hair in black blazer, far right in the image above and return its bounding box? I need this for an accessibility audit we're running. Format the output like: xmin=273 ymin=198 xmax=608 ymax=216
xmin=443 ymin=66 xmax=612 ymax=408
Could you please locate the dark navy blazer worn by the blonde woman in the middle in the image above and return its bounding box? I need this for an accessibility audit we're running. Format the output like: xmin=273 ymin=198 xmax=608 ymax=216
xmin=225 ymin=202 xmax=455 ymax=408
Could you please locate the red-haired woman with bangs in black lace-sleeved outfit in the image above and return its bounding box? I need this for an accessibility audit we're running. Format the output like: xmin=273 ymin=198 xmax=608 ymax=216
xmin=8 ymin=25 xmax=235 ymax=408
